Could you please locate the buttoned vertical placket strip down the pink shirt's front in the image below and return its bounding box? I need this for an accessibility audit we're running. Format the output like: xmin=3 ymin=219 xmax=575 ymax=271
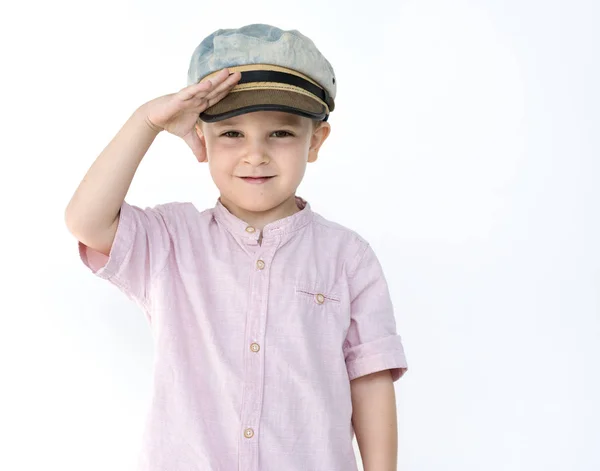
xmin=239 ymin=230 xmax=280 ymax=471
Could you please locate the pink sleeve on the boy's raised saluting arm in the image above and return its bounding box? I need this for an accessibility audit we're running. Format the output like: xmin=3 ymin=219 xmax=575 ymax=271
xmin=78 ymin=201 xmax=172 ymax=309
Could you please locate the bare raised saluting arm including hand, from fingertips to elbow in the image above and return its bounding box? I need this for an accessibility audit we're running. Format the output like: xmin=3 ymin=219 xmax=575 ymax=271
xmin=65 ymin=68 xmax=242 ymax=256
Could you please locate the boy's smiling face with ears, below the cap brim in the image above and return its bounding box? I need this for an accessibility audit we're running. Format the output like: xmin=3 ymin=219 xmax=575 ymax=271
xmin=196 ymin=111 xmax=330 ymax=212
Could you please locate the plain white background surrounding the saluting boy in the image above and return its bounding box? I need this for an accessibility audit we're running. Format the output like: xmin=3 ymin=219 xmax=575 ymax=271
xmin=0 ymin=0 xmax=600 ymax=471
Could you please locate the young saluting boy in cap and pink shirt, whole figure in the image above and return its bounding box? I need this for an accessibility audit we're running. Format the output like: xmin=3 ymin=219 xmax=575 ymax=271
xmin=65 ymin=24 xmax=407 ymax=471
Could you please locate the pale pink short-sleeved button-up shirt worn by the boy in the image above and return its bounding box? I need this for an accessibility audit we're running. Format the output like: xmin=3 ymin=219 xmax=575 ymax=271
xmin=79 ymin=198 xmax=407 ymax=471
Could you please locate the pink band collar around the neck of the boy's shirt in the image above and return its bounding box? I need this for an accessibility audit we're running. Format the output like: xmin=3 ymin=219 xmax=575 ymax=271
xmin=214 ymin=196 xmax=313 ymax=243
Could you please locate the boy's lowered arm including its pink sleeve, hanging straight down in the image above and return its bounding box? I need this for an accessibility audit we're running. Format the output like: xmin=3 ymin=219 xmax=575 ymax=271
xmin=343 ymin=244 xmax=408 ymax=471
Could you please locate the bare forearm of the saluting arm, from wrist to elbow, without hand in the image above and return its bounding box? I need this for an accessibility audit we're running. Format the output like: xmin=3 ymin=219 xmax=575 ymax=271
xmin=65 ymin=105 xmax=158 ymax=233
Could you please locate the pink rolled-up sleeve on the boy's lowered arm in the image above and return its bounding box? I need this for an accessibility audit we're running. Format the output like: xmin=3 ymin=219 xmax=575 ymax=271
xmin=344 ymin=244 xmax=408 ymax=381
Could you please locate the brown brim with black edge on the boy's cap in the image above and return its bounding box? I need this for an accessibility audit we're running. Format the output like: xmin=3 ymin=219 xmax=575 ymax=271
xmin=200 ymin=89 xmax=328 ymax=123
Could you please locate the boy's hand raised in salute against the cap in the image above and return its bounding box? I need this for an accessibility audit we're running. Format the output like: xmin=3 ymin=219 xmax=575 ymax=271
xmin=140 ymin=68 xmax=242 ymax=162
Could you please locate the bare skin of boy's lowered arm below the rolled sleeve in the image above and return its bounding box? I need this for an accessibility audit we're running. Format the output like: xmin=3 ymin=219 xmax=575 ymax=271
xmin=350 ymin=370 xmax=398 ymax=471
